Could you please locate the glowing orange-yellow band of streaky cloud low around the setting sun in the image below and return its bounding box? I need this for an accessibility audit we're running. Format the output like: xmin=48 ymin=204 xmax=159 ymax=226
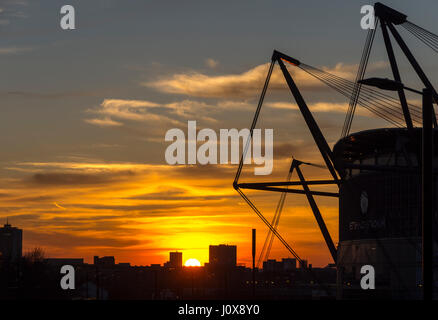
xmin=0 ymin=159 xmax=336 ymax=265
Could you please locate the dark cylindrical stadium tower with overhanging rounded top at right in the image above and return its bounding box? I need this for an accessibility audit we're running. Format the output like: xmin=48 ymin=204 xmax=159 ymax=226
xmin=333 ymin=128 xmax=438 ymax=299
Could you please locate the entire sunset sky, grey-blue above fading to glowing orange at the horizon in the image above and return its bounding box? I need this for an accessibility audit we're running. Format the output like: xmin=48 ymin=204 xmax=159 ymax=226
xmin=0 ymin=0 xmax=438 ymax=266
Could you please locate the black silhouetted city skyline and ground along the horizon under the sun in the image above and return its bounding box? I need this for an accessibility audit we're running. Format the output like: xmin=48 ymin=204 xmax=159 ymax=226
xmin=0 ymin=225 xmax=336 ymax=300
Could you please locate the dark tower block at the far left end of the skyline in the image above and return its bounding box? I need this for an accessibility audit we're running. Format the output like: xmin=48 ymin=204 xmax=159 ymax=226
xmin=0 ymin=222 xmax=23 ymax=263
